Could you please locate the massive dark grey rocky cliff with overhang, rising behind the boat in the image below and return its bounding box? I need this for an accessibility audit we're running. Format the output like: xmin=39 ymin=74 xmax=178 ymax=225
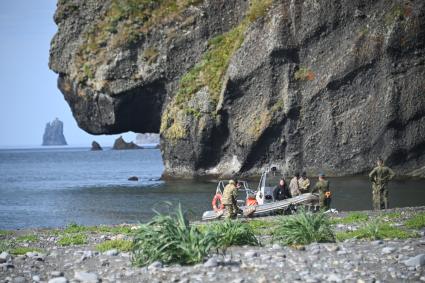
xmin=50 ymin=0 xmax=425 ymax=177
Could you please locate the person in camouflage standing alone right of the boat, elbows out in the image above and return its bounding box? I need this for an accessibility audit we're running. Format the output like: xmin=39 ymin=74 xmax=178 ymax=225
xmin=369 ymin=158 xmax=395 ymax=210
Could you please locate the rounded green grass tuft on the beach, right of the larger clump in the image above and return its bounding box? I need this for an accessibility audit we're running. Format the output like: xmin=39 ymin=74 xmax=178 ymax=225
xmin=273 ymin=210 xmax=335 ymax=245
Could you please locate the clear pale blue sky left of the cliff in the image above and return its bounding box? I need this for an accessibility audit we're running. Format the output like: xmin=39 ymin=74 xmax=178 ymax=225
xmin=0 ymin=0 xmax=135 ymax=147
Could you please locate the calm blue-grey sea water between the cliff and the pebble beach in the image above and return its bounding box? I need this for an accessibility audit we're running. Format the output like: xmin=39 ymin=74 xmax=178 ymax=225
xmin=0 ymin=147 xmax=425 ymax=229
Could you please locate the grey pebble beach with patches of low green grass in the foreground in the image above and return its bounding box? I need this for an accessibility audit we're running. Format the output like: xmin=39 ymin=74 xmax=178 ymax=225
xmin=0 ymin=206 xmax=425 ymax=283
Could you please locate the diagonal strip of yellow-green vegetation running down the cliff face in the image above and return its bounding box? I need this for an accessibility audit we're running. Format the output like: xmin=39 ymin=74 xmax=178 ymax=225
xmin=161 ymin=0 xmax=273 ymax=140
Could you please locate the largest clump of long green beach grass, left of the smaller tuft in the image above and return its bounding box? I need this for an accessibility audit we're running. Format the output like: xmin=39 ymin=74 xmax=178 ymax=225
xmin=132 ymin=205 xmax=260 ymax=266
